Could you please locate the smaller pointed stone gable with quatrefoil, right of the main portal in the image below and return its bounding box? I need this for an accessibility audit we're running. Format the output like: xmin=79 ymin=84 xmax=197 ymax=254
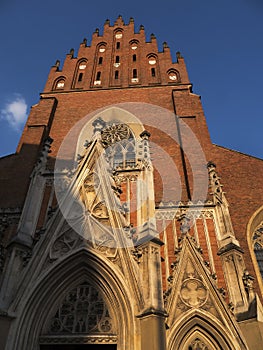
xmin=166 ymin=234 xmax=250 ymax=349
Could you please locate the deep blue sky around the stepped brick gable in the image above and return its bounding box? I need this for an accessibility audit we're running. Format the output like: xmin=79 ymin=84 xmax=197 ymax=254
xmin=0 ymin=0 xmax=263 ymax=158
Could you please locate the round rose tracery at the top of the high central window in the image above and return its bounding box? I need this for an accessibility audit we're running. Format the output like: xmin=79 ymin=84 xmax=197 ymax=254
xmin=101 ymin=124 xmax=130 ymax=146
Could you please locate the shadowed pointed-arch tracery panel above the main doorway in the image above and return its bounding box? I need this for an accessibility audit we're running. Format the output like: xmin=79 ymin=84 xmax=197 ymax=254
xmin=49 ymin=282 xmax=114 ymax=334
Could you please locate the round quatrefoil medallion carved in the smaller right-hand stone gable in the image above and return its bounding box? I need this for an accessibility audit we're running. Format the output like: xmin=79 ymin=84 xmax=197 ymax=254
xmin=180 ymin=278 xmax=208 ymax=308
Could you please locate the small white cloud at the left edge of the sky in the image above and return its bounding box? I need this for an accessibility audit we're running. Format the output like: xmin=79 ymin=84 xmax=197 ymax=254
xmin=1 ymin=95 xmax=27 ymax=131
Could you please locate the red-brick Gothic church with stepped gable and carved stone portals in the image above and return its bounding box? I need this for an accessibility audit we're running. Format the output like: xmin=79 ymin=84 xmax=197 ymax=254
xmin=0 ymin=16 xmax=263 ymax=350
